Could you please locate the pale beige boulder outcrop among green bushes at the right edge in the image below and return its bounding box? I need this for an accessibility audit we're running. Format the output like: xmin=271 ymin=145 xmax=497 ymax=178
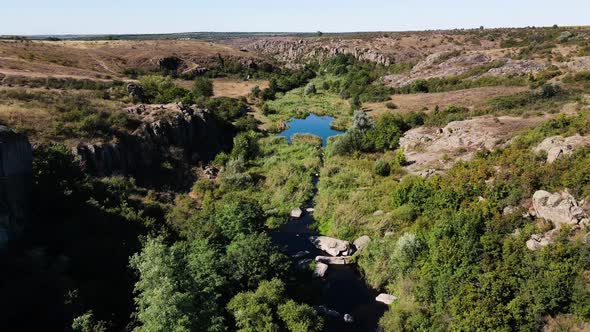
xmin=526 ymin=190 xmax=590 ymax=250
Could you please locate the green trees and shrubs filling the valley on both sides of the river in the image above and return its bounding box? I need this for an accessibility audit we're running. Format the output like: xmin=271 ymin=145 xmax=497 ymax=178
xmin=0 ymin=28 xmax=590 ymax=332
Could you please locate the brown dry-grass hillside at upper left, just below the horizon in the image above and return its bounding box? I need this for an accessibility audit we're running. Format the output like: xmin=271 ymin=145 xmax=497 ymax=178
xmin=0 ymin=40 xmax=264 ymax=79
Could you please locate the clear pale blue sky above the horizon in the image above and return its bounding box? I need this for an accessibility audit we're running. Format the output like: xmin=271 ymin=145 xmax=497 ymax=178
xmin=0 ymin=0 xmax=590 ymax=35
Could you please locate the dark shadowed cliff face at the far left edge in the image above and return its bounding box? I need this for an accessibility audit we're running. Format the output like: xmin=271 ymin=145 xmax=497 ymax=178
xmin=0 ymin=126 xmax=33 ymax=247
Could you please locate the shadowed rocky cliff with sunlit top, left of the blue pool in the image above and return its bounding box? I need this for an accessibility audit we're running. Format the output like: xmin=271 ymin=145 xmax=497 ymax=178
xmin=74 ymin=104 xmax=233 ymax=176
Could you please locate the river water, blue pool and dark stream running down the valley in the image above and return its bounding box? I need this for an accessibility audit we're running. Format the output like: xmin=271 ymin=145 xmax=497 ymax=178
xmin=271 ymin=118 xmax=387 ymax=332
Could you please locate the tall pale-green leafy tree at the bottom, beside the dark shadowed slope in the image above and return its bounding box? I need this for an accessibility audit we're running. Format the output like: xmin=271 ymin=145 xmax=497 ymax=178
xmin=131 ymin=238 xmax=225 ymax=332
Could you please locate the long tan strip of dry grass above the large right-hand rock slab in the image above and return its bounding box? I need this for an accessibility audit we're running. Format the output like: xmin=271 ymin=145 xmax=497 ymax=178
xmin=363 ymin=86 xmax=528 ymax=116
